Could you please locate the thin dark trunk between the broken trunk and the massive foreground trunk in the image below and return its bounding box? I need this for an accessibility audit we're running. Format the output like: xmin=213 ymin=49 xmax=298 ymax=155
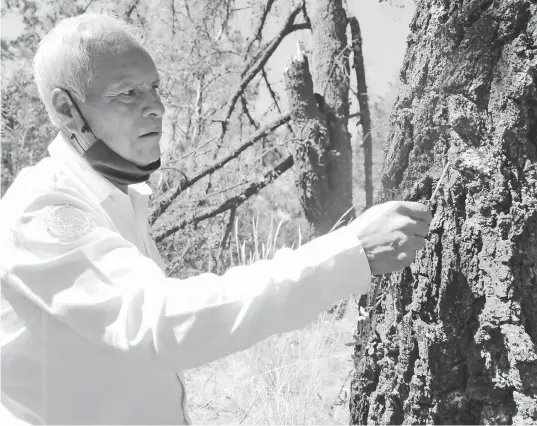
xmin=349 ymin=17 xmax=373 ymax=209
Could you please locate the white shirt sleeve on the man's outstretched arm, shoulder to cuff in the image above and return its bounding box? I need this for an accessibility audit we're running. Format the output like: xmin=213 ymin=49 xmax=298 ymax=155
xmin=2 ymin=191 xmax=370 ymax=370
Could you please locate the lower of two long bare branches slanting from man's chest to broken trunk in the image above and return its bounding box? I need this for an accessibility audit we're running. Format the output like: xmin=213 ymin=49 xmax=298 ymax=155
xmin=154 ymin=155 xmax=294 ymax=243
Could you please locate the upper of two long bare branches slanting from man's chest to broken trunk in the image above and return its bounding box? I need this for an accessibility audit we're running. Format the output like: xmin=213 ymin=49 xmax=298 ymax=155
xmin=149 ymin=114 xmax=291 ymax=225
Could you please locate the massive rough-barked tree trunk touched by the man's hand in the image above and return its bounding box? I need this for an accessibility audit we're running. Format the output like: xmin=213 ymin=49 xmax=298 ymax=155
xmin=350 ymin=0 xmax=537 ymax=424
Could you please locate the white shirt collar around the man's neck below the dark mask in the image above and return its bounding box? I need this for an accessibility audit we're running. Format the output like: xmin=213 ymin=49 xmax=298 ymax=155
xmin=48 ymin=132 xmax=153 ymax=203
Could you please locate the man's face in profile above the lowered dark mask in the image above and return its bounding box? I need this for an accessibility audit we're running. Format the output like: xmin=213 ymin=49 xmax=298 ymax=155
xmin=81 ymin=39 xmax=164 ymax=166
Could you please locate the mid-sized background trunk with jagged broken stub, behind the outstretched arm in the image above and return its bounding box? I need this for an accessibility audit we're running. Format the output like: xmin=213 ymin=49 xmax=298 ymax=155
xmin=285 ymin=0 xmax=354 ymax=236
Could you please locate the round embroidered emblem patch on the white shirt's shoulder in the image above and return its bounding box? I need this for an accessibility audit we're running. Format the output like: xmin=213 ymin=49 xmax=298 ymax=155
xmin=45 ymin=203 xmax=93 ymax=242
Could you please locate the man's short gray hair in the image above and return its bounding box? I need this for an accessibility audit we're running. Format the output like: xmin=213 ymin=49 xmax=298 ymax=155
xmin=33 ymin=13 xmax=143 ymax=128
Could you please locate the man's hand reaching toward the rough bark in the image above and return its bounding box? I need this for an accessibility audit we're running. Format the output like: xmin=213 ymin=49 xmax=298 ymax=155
xmin=348 ymin=201 xmax=432 ymax=275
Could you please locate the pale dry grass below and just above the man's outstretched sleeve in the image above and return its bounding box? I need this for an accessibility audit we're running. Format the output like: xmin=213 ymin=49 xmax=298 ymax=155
xmin=185 ymin=215 xmax=359 ymax=425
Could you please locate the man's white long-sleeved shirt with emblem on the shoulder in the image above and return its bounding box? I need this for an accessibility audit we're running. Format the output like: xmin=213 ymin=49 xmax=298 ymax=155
xmin=0 ymin=134 xmax=370 ymax=424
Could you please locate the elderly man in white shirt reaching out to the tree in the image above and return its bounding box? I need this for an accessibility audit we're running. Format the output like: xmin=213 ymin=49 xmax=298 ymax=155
xmin=0 ymin=14 xmax=431 ymax=424
